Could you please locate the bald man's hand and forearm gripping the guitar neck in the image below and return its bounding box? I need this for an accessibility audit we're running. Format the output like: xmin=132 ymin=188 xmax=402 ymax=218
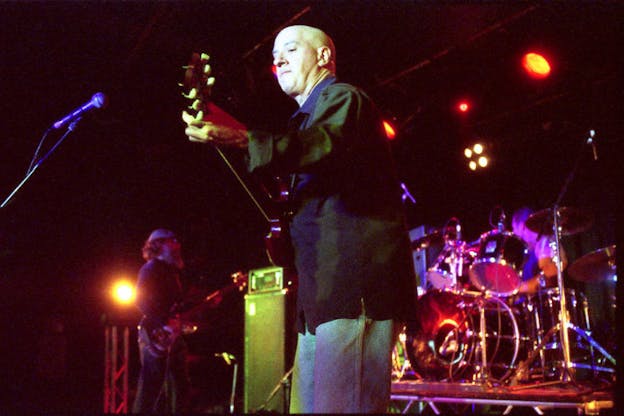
xmin=182 ymin=111 xmax=248 ymax=149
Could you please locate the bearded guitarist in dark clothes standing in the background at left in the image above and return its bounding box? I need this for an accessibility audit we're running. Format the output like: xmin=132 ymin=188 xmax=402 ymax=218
xmin=132 ymin=229 xmax=190 ymax=413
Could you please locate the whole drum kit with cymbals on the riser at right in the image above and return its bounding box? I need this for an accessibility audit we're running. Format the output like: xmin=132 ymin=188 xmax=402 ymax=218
xmin=393 ymin=208 xmax=616 ymax=385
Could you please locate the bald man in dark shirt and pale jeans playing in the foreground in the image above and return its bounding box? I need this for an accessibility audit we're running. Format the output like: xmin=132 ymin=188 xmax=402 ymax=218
xmin=183 ymin=25 xmax=416 ymax=413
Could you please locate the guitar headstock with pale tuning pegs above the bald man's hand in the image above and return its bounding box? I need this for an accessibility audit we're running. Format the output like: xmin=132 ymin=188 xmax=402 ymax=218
xmin=180 ymin=52 xmax=215 ymax=113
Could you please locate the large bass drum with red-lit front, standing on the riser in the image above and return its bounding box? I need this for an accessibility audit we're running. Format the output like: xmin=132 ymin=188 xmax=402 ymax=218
xmin=406 ymin=290 xmax=520 ymax=382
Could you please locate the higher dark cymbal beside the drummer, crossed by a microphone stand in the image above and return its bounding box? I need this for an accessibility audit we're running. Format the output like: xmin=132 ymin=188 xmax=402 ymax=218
xmin=526 ymin=207 xmax=594 ymax=235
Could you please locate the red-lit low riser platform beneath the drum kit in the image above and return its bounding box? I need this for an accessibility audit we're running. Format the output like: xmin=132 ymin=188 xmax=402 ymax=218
xmin=392 ymin=380 xmax=614 ymax=415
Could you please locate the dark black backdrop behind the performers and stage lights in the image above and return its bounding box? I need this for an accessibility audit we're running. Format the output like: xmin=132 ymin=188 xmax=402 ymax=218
xmin=0 ymin=1 xmax=624 ymax=411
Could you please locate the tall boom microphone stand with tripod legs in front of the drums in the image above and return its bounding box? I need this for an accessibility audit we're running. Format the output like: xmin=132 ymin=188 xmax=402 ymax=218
xmin=512 ymin=130 xmax=616 ymax=388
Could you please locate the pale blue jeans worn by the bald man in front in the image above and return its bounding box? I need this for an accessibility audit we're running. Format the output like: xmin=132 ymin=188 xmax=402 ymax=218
xmin=290 ymin=315 xmax=402 ymax=413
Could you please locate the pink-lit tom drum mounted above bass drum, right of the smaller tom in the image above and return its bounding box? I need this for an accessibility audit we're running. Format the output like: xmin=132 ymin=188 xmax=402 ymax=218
xmin=468 ymin=230 xmax=528 ymax=296
